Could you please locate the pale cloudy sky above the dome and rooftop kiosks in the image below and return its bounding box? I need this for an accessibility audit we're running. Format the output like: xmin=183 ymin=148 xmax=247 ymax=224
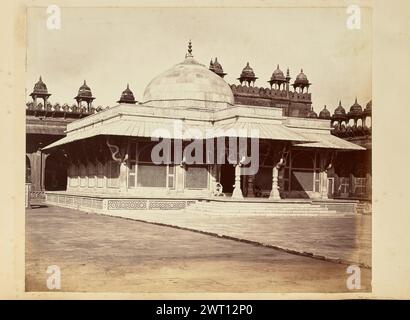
xmin=26 ymin=8 xmax=372 ymax=112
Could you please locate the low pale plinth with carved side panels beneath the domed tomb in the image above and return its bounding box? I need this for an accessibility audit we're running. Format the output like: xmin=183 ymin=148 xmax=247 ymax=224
xmin=46 ymin=191 xmax=358 ymax=215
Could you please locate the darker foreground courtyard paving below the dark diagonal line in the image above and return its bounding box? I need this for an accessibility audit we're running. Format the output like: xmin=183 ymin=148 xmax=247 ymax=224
xmin=26 ymin=207 xmax=371 ymax=292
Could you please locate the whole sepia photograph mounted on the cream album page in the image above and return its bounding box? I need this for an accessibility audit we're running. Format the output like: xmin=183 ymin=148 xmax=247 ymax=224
xmin=24 ymin=5 xmax=373 ymax=296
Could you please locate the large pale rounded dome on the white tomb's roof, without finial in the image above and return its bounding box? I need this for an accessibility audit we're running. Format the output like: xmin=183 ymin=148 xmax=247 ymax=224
xmin=143 ymin=56 xmax=234 ymax=109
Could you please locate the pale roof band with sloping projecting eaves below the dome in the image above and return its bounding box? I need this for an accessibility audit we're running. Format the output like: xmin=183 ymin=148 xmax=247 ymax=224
xmin=44 ymin=104 xmax=363 ymax=150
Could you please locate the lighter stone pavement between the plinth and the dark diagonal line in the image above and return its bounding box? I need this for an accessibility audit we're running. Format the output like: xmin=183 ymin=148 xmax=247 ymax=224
xmin=105 ymin=211 xmax=372 ymax=267
